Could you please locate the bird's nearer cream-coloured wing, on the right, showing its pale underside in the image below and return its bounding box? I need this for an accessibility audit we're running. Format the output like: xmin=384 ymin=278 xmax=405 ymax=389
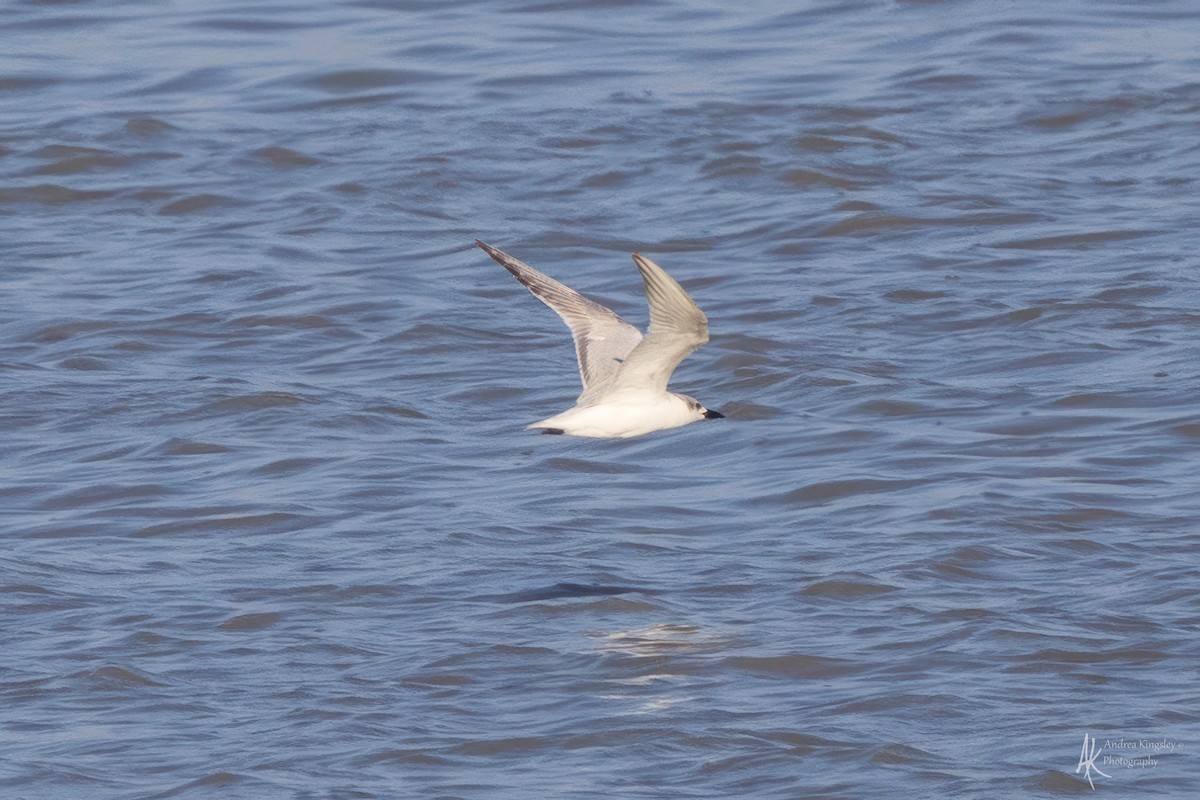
xmin=608 ymin=253 xmax=708 ymax=392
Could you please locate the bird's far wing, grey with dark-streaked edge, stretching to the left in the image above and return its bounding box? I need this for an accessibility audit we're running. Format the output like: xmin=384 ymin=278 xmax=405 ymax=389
xmin=475 ymin=240 xmax=648 ymax=405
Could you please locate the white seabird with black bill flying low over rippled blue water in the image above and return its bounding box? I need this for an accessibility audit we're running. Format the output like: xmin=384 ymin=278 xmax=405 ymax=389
xmin=475 ymin=240 xmax=725 ymax=439
